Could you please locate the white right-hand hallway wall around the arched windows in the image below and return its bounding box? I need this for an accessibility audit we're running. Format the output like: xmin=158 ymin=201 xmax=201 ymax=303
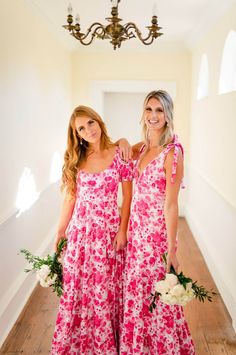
xmin=186 ymin=5 xmax=236 ymax=329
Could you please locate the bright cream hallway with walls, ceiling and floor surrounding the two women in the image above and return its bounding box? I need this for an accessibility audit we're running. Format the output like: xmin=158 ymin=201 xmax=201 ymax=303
xmin=0 ymin=0 xmax=236 ymax=355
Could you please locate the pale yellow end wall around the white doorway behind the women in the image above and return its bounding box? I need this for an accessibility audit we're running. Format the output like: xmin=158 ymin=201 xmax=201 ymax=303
xmin=72 ymin=50 xmax=191 ymax=158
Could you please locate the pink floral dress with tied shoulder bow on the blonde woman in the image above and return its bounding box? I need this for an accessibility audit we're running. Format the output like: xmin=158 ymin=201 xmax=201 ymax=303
xmin=120 ymin=136 xmax=195 ymax=355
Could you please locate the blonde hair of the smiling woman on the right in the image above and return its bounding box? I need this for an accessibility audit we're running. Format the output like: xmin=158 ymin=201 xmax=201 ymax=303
xmin=141 ymin=90 xmax=174 ymax=147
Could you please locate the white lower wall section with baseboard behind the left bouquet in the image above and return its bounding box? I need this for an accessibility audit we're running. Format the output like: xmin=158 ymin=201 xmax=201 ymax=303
xmin=0 ymin=182 xmax=62 ymax=346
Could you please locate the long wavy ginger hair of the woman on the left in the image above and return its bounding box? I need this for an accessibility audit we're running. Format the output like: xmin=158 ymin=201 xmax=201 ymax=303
xmin=61 ymin=106 xmax=113 ymax=197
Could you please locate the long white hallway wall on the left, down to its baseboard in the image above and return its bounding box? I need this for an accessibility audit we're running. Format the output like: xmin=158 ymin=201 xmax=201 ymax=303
xmin=0 ymin=0 xmax=71 ymax=344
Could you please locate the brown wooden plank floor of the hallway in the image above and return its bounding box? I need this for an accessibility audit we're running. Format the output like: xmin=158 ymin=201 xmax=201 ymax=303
xmin=0 ymin=218 xmax=236 ymax=355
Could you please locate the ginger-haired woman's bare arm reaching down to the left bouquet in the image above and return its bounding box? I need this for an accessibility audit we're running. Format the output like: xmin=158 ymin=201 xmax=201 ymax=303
xmin=54 ymin=195 xmax=75 ymax=251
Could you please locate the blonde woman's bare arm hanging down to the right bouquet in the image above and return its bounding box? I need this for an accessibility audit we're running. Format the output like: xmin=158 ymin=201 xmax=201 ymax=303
xmin=164 ymin=150 xmax=183 ymax=273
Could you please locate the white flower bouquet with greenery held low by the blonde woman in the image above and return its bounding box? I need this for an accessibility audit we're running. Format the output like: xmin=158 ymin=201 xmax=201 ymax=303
xmin=149 ymin=255 xmax=216 ymax=312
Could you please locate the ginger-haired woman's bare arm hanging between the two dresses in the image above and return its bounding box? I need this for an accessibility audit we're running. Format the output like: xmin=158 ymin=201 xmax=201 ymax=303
xmin=114 ymin=181 xmax=132 ymax=251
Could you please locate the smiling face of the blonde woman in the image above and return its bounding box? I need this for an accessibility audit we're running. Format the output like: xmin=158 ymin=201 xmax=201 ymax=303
xmin=144 ymin=97 xmax=166 ymax=130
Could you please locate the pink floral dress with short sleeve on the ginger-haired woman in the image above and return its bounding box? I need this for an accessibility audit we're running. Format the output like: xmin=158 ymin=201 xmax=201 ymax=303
xmin=51 ymin=150 xmax=133 ymax=355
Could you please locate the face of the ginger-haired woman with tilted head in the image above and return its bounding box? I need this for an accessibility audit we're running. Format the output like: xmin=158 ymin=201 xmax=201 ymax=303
xmin=75 ymin=116 xmax=102 ymax=144
